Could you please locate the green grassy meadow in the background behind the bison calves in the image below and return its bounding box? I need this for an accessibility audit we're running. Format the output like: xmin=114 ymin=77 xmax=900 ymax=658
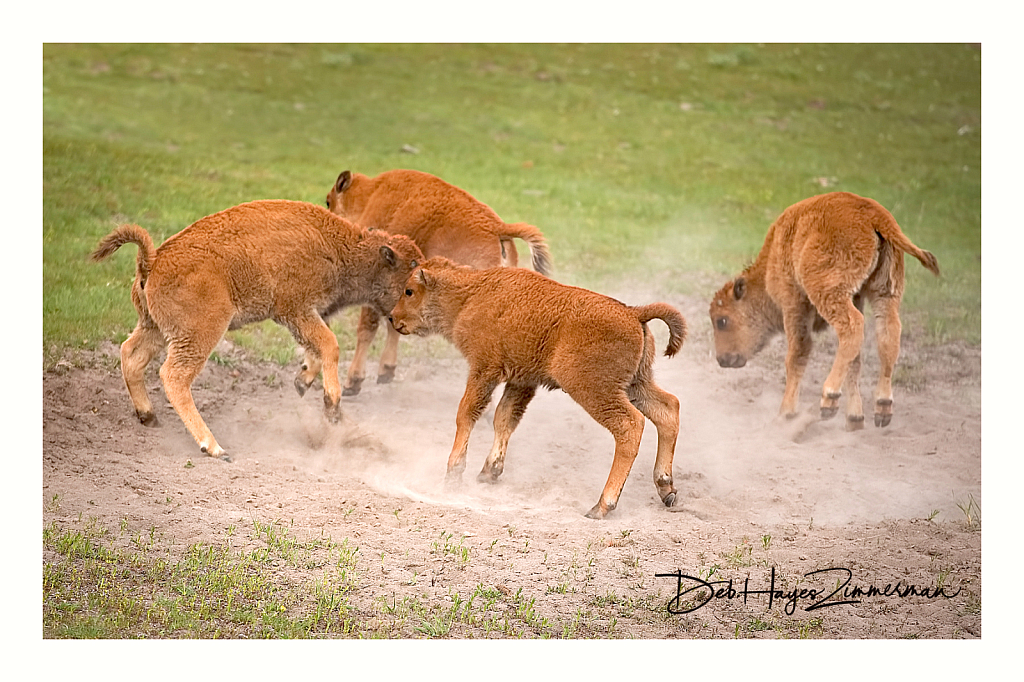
xmin=43 ymin=44 xmax=981 ymax=366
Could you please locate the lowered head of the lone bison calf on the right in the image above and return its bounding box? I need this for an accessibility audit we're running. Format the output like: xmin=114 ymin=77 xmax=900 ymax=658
xmin=710 ymin=276 xmax=773 ymax=367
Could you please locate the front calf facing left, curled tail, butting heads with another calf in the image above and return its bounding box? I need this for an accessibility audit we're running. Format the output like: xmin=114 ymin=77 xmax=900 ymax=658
xmin=390 ymin=258 xmax=686 ymax=518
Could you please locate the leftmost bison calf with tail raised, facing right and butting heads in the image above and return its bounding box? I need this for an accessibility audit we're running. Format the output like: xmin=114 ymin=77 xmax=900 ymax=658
xmin=92 ymin=201 xmax=423 ymax=461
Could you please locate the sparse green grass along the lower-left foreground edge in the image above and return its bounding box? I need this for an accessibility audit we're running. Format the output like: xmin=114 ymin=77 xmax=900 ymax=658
xmin=42 ymin=516 xmax=598 ymax=639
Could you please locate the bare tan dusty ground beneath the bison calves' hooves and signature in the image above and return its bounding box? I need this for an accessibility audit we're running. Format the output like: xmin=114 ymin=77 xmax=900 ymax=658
xmin=42 ymin=296 xmax=981 ymax=638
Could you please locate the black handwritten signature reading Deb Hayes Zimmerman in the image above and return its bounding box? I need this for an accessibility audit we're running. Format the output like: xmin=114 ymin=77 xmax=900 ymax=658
xmin=654 ymin=566 xmax=963 ymax=615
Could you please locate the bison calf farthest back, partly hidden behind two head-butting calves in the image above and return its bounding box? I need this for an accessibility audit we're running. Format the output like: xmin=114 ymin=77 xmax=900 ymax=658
xmin=327 ymin=170 xmax=551 ymax=395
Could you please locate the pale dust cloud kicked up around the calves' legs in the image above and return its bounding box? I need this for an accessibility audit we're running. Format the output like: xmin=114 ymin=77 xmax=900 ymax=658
xmin=185 ymin=284 xmax=981 ymax=524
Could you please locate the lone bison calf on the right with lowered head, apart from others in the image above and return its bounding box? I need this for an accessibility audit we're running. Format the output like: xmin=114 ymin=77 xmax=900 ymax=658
xmin=711 ymin=191 xmax=939 ymax=430
